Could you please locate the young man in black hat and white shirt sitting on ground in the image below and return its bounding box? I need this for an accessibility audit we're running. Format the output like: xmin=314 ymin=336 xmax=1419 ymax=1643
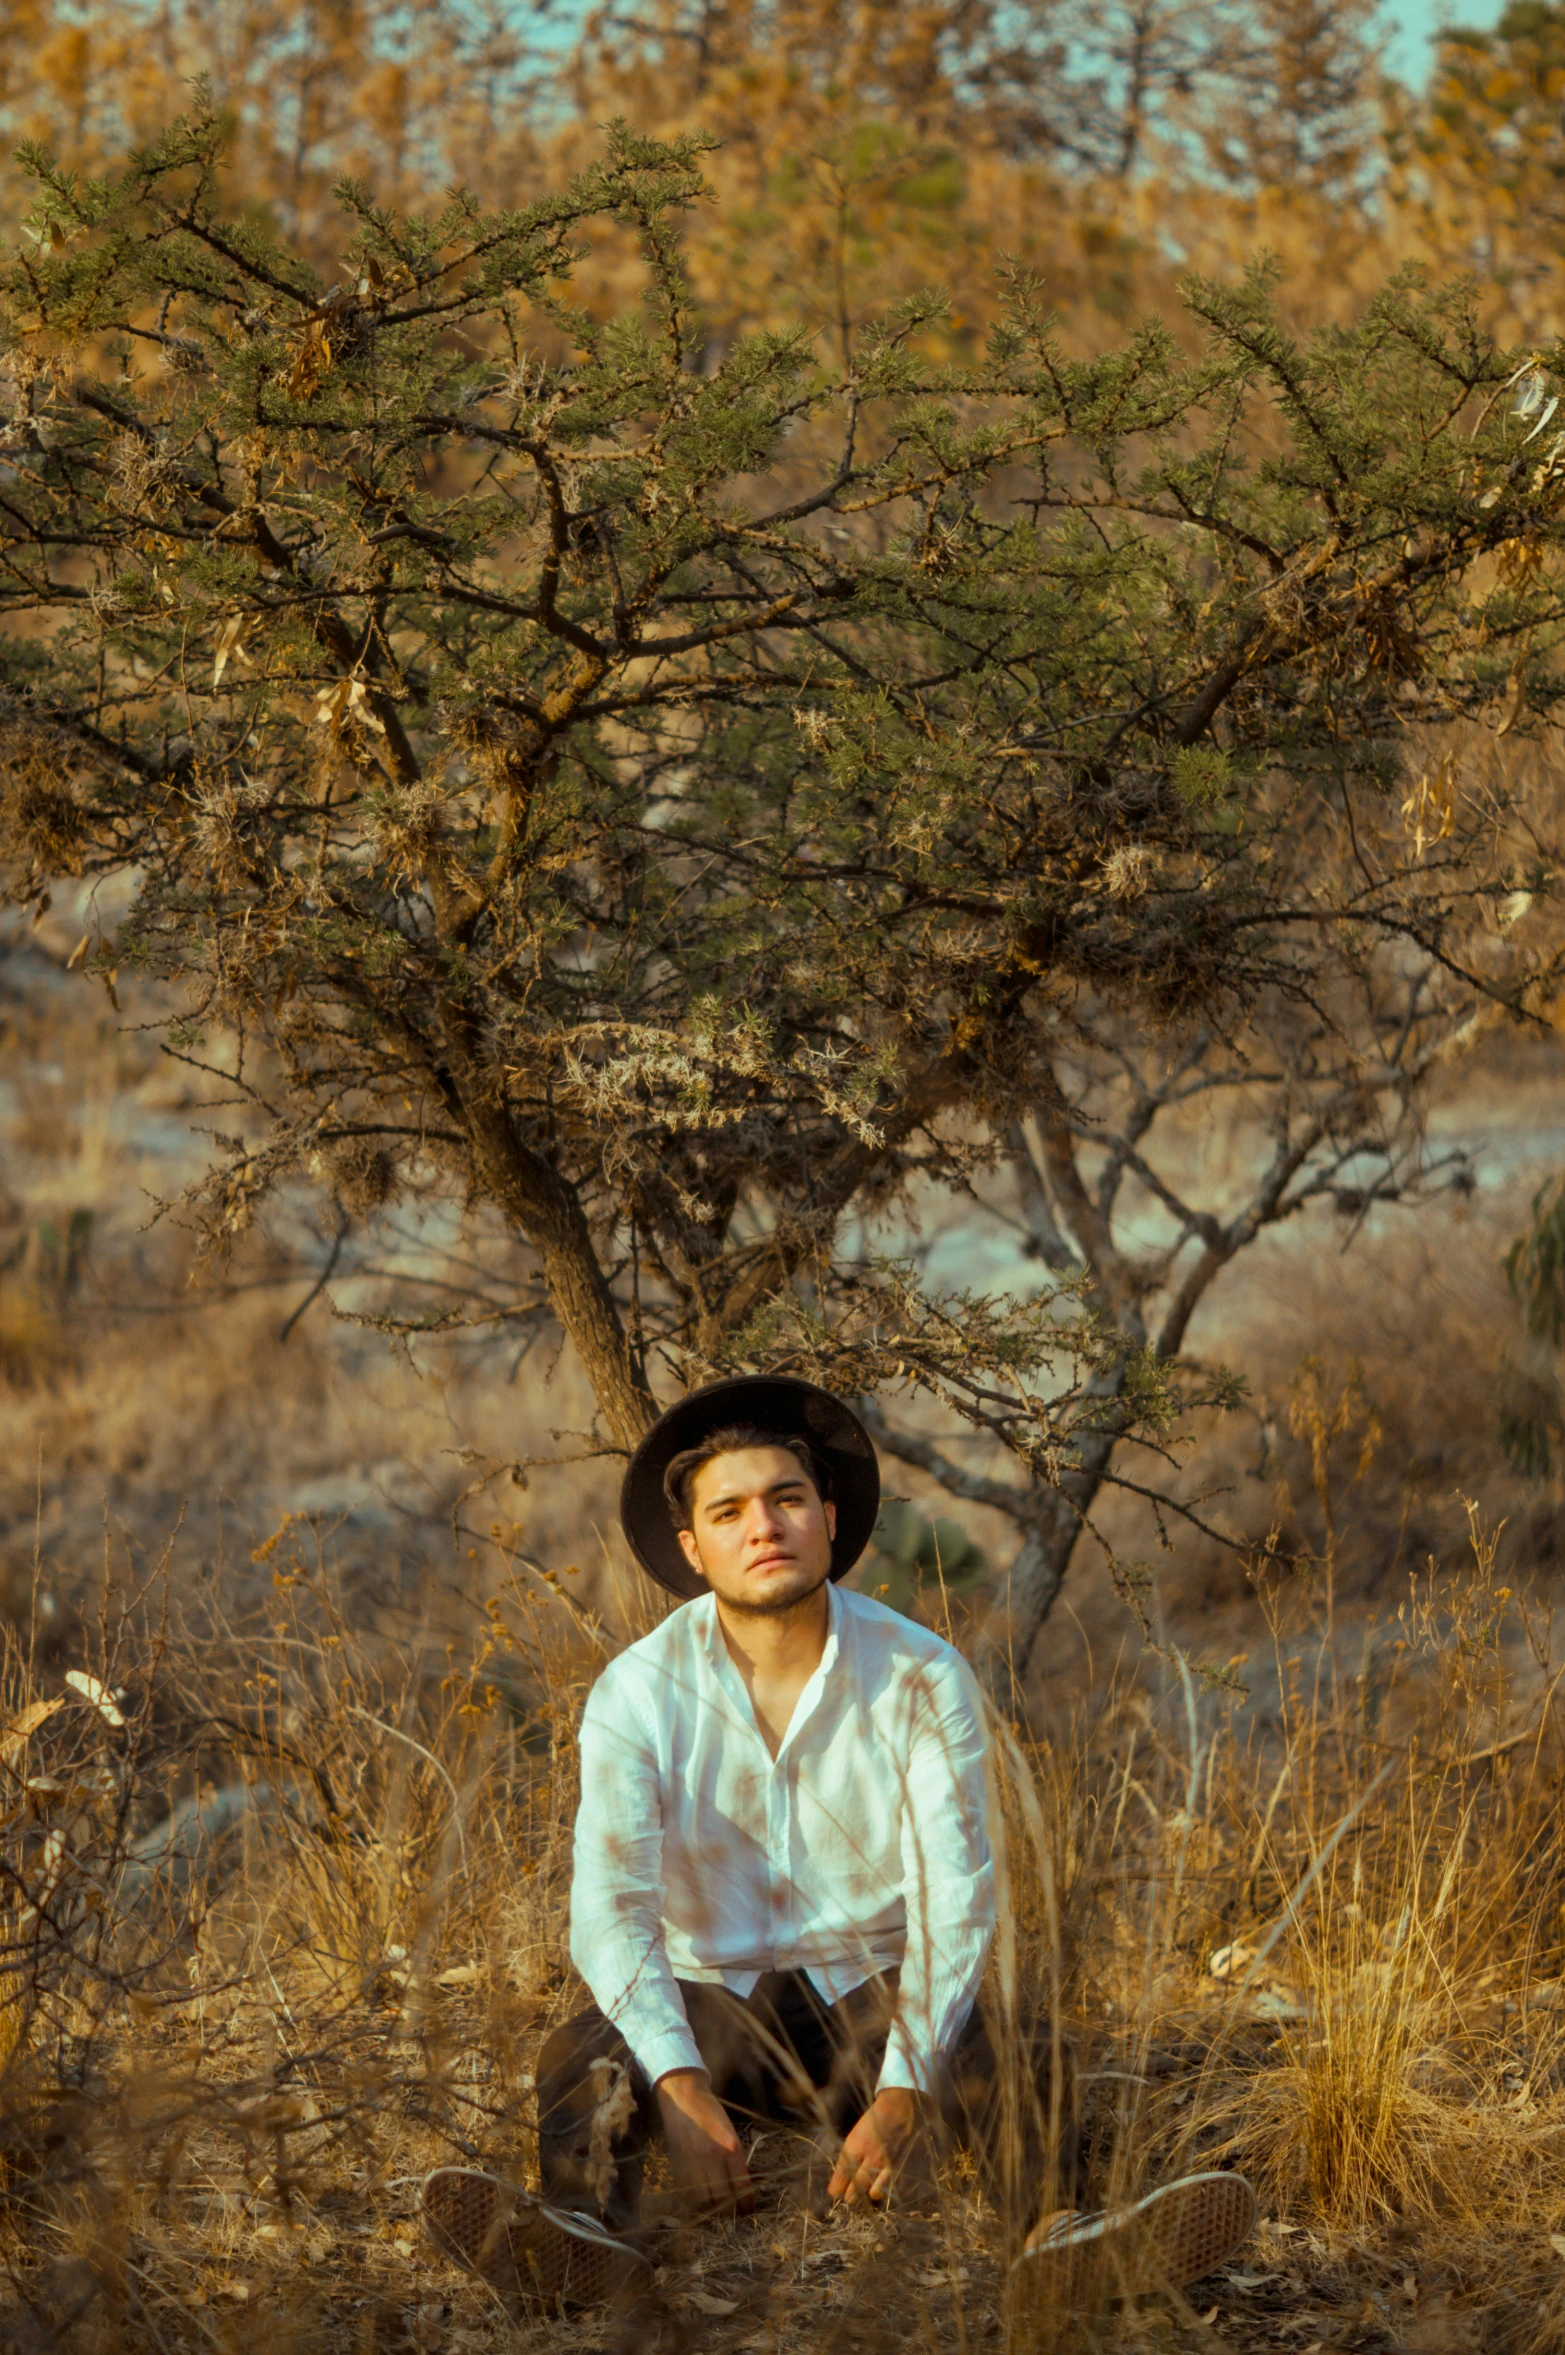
xmin=426 ymin=1378 xmax=1254 ymax=2296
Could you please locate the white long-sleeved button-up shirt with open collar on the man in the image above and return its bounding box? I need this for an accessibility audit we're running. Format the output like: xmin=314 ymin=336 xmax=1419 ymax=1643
xmin=570 ymin=1587 xmax=995 ymax=2091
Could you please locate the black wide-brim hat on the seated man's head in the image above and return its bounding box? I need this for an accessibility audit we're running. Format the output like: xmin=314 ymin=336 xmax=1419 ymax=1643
xmin=619 ymin=1373 xmax=880 ymax=1601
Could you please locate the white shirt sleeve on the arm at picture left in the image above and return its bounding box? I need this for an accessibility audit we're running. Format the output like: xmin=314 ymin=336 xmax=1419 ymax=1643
xmin=570 ymin=1670 xmax=704 ymax=2084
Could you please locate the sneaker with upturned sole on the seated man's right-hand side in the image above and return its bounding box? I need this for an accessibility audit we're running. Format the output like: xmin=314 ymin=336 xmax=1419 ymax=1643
xmin=1012 ymin=2174 xmax=1254 ymax=2310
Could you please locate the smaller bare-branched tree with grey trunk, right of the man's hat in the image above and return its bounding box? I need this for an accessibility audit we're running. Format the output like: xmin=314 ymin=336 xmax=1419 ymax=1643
xmin=871 ymin=913 xmax=1485 ymax=1681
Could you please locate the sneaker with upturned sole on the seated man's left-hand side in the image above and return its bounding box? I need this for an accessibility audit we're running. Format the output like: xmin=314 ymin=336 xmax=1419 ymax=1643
xmin=419 ymin=2167 xmax=652 ymax=2306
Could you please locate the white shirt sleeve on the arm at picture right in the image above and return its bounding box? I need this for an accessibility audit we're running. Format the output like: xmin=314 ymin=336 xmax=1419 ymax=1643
xmin=880 ymin=1660 xmax=995 ymax=2094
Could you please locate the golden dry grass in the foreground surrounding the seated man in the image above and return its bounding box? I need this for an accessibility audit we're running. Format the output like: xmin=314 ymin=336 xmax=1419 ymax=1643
xmin=0 ymin=1488 xmax=1565 ymax=2355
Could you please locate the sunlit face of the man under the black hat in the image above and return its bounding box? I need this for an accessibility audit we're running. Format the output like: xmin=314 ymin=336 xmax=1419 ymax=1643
xmin=680 ymin=1448 xmax=838 ymax=1613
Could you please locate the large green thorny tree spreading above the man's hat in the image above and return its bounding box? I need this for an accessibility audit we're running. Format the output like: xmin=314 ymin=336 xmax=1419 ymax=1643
xmin=0 ymin=118 xmax=1565 ymax=1695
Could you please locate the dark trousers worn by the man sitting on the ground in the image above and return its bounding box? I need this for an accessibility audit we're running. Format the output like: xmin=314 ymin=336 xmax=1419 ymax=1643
xmin=537 ymin=1971 xmax=1050 ymax=2230
